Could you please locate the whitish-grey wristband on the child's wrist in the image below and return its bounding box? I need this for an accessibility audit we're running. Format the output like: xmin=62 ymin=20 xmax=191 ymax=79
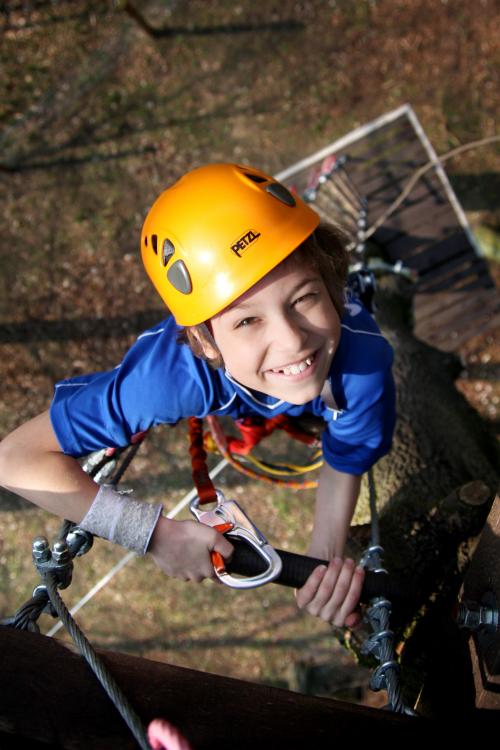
xmin=78 ymin=485 xmax=163 ymax=555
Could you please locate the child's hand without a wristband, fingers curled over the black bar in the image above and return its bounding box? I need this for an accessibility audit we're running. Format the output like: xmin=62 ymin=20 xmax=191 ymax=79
xmin=295 ymin=557 xmax=365 ymax=628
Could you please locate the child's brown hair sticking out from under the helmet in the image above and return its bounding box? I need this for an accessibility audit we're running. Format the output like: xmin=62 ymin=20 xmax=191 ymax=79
xmin=178 ymin=222 xmax=349 ymax=369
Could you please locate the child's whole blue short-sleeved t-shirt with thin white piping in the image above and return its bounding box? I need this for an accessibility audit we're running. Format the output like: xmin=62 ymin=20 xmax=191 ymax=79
xmin=51 ymin=301 xmax=395 ymax=474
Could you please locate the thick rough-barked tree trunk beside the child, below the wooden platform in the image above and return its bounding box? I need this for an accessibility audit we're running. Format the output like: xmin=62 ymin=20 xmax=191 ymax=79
xmin=342 ymin=277 xmax=498 ymax=712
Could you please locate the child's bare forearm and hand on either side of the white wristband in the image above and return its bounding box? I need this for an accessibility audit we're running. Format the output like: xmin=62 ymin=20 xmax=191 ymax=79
xmin=0 ymin=411 xmax=233 ymax=581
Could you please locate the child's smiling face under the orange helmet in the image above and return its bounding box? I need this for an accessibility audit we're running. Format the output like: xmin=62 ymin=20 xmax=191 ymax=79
xmin=205 ymin=256 xmax=341 ymax=404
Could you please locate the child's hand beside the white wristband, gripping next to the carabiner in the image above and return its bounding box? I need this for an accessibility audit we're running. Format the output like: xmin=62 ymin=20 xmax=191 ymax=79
xmin=148 ymin=516 xmax=233 ymax=582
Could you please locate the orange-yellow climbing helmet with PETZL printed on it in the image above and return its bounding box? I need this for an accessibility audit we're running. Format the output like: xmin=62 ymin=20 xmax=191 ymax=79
xmin=141 ymin=164 xmax=319 ymax=326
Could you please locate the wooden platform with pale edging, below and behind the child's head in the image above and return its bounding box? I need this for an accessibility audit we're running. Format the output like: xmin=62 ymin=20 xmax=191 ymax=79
xmin=276 ymin=104 xmax=500 ymax=351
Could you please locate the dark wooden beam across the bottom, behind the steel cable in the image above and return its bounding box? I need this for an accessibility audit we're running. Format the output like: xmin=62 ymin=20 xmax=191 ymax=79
xmin=0 ymin=627 xmax=500 ymax=750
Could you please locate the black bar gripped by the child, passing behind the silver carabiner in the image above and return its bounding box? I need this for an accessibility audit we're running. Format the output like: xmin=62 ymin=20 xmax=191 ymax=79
xmin=226 ymin=539 xmax=415 ymax=603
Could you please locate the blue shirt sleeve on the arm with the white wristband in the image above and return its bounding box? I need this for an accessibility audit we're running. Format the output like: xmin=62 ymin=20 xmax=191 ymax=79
xmin=50 ymin=319 xmax=214 ymax=457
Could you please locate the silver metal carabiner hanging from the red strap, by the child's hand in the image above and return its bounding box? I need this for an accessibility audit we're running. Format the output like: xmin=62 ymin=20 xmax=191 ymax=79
xmin=189 ymin=490 xmax=283 ymax=589
